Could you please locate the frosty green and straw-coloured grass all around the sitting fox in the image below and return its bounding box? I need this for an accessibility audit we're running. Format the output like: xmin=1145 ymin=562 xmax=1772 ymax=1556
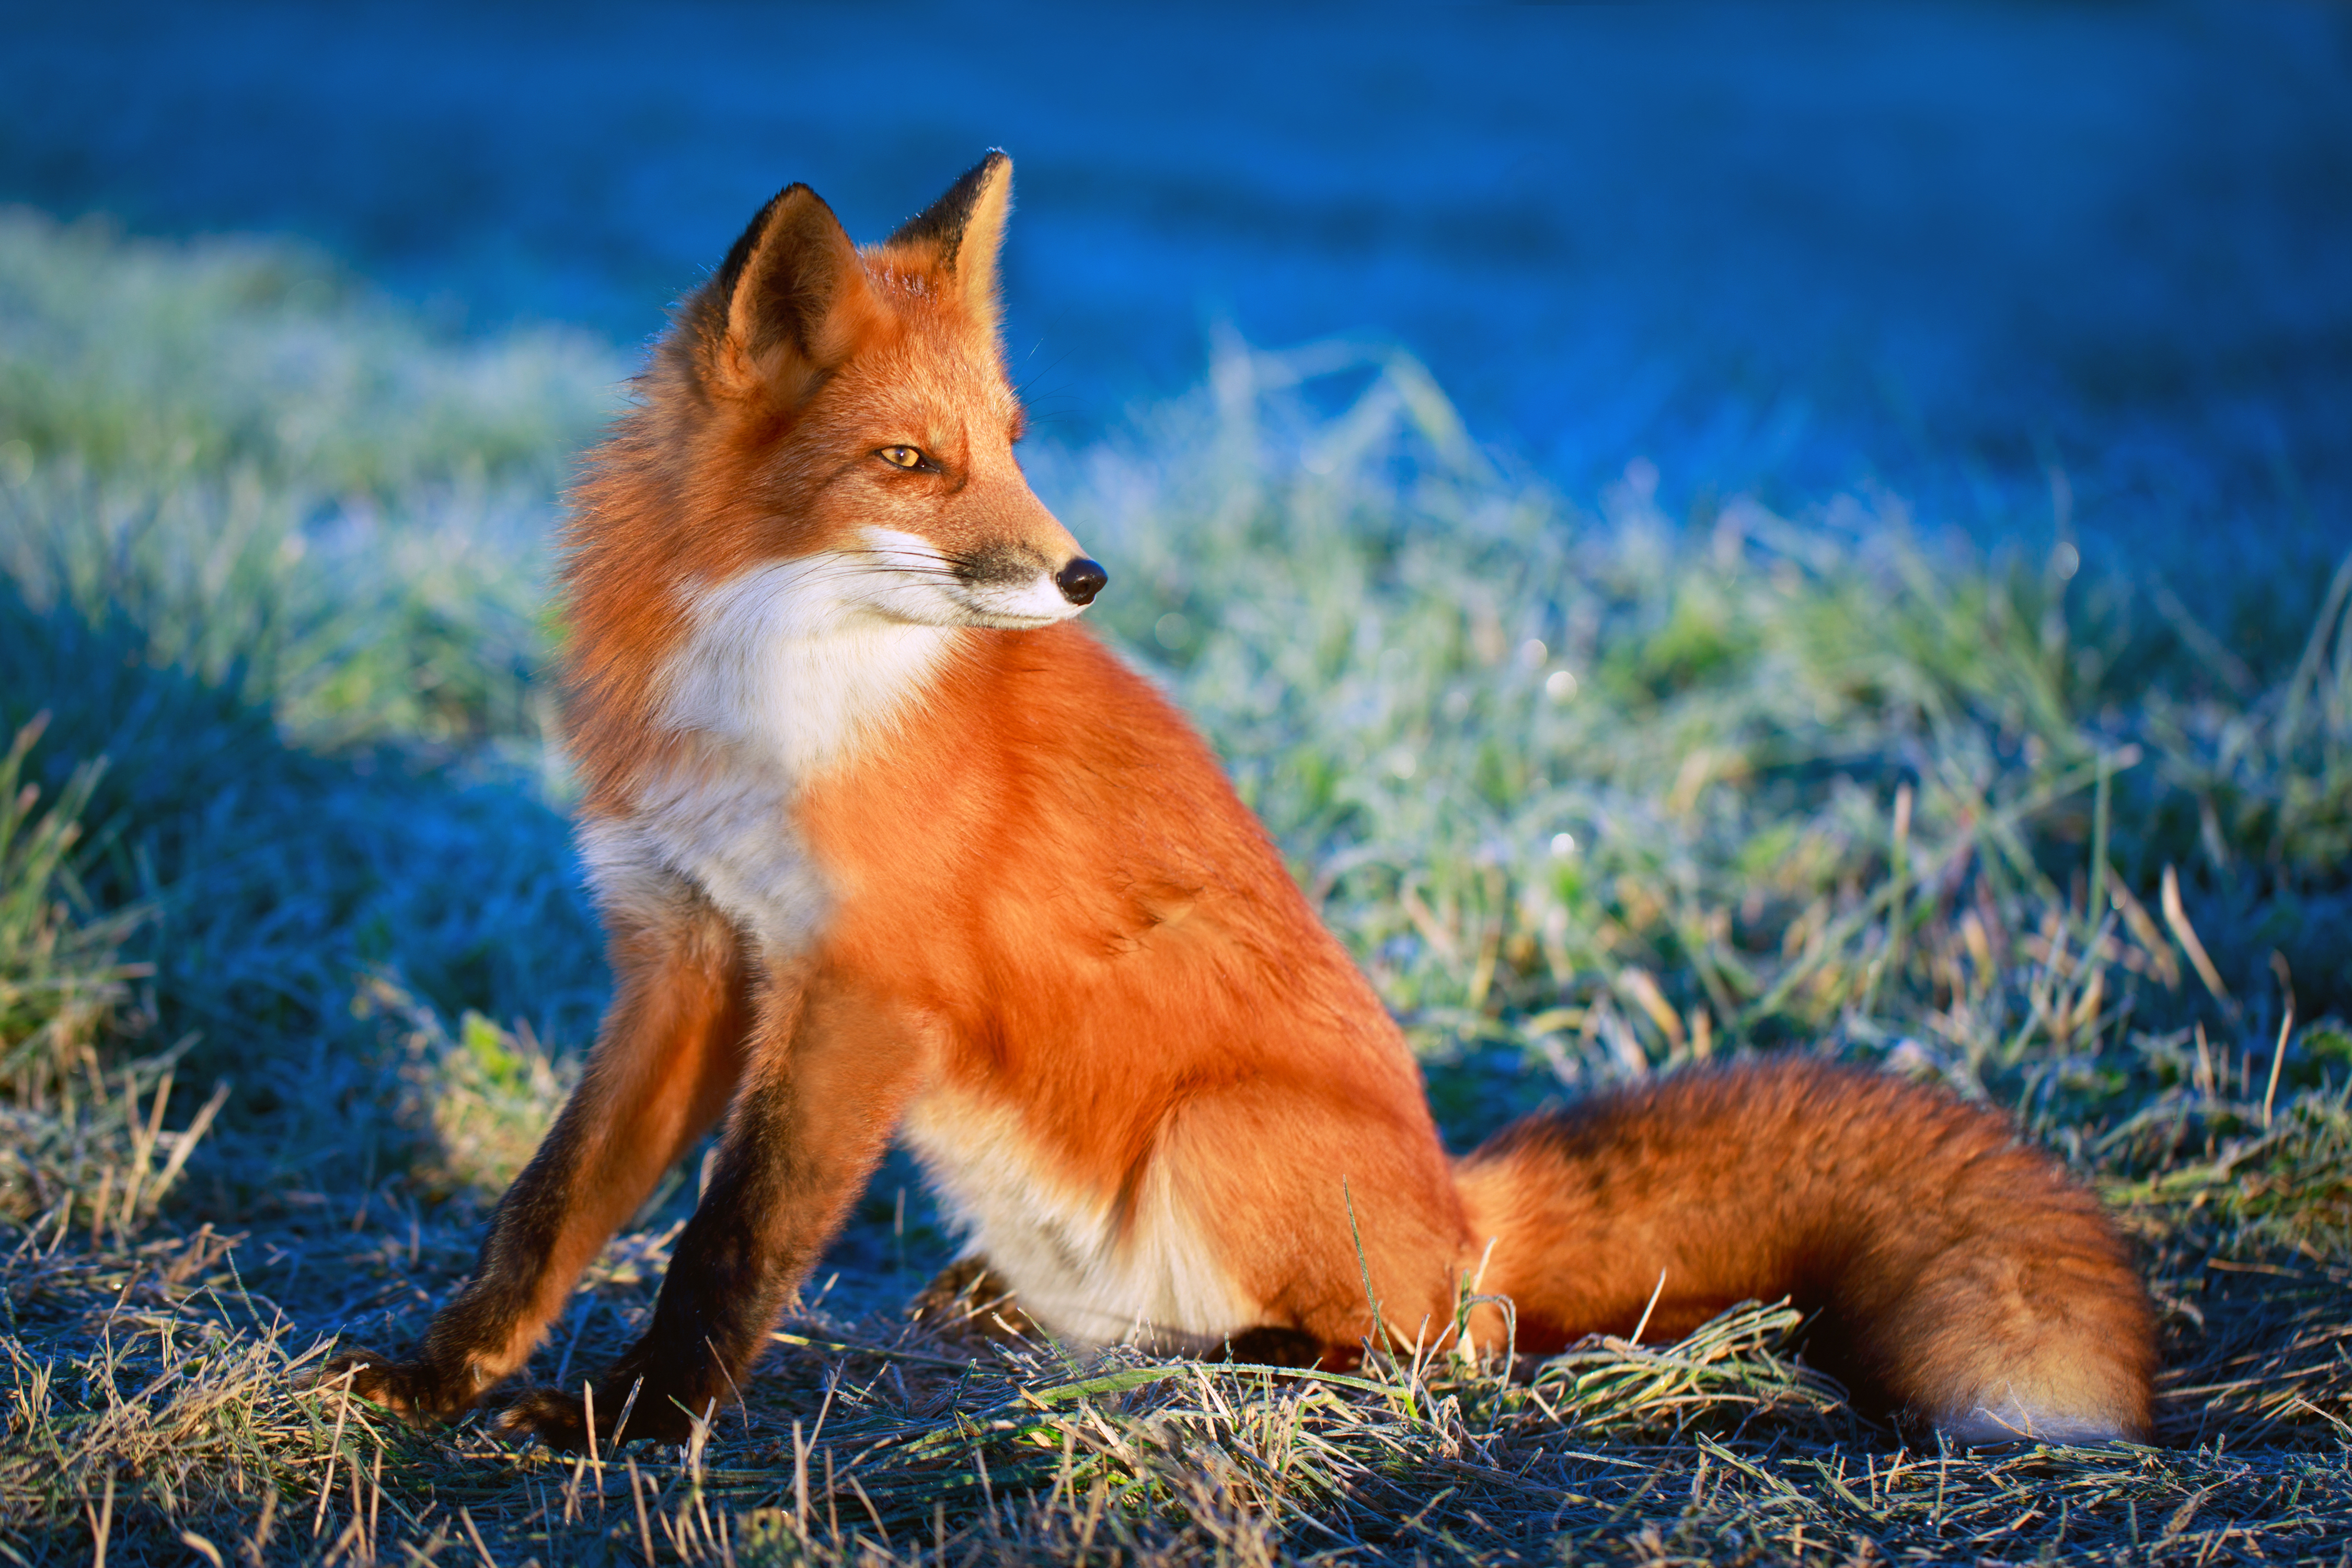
xmin=0 ymin=216 xmax=2352 ymax=1563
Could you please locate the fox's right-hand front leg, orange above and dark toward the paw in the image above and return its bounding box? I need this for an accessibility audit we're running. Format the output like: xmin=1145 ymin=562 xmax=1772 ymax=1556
xmin=499 ymin=973 xmax=925 ymax=1448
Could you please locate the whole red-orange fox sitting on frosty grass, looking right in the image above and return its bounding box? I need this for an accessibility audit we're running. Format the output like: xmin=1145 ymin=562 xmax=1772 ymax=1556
xmin=341 ymin=153 xmax=2154 ymax=1446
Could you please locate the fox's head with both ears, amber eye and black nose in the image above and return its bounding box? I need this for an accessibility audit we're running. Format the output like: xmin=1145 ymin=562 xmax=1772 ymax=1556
xmin=649 ymin=153 xmax=1105 ymax=630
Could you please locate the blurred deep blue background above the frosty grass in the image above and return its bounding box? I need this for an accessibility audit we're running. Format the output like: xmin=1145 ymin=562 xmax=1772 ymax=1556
xmin=0 ymin=0 xmax=2352 ymax=578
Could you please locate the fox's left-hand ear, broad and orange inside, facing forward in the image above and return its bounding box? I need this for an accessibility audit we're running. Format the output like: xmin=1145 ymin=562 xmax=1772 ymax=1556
xmin=696 ymin=186 xmax=882 ymax=402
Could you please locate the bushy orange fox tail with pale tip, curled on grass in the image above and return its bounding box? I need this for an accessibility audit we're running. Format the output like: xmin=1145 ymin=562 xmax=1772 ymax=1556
xmin=1458 ymin=1058 xmax=2157 ymax=1441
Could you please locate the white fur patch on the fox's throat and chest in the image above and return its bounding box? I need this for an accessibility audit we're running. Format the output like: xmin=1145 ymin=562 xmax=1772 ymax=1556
xmin=581 ymin=552 xmax=960 ymax=952
